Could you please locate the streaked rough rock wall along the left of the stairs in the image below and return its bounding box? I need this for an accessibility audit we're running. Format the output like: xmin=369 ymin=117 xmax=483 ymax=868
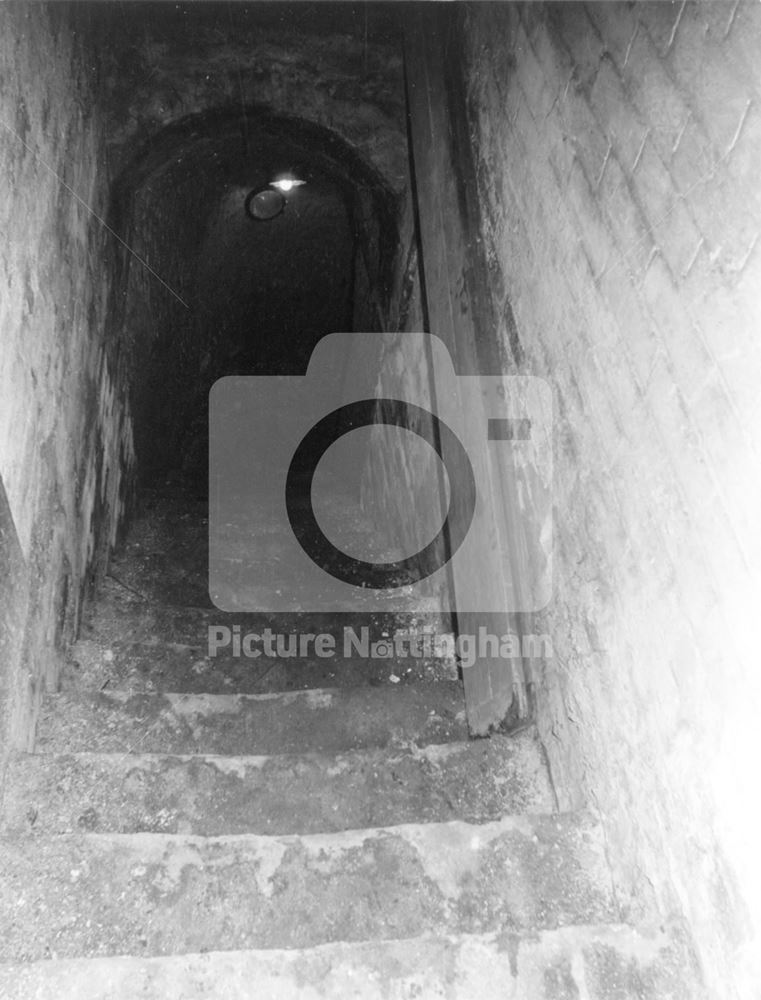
xmin=0 ymin=3 xmax=131 ymax=764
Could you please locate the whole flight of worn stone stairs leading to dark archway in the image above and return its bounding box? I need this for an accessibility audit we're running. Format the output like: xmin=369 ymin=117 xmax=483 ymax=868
xmin=0 ymin=488 xmax=698 ymax=1000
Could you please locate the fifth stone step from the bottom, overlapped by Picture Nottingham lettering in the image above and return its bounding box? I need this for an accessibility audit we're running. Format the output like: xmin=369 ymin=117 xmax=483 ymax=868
xmin=62 ymin=639 xmax=457 ymax=694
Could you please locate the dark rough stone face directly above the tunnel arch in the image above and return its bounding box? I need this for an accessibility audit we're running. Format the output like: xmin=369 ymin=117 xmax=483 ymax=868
xmin=84 ymin=0 xmax=407 ymax=190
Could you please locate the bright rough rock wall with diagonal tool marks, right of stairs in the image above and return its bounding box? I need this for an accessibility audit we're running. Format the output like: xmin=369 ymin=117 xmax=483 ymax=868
xmin=463 ymin=2 xmax=761 ymax=998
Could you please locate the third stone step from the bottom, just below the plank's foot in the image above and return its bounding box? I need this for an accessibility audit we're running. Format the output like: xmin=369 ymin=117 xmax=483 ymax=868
xmin=3 ymin=731 xmax=555 ymax=836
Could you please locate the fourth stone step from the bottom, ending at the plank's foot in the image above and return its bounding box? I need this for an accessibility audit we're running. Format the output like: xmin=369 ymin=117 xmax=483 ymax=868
xmin=36 ymin=681 xmax=468 ymax=756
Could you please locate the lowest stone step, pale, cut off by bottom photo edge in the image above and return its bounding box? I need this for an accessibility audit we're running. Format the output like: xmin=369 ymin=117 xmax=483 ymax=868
xmin=0 ymin=924 xmax=703 ymax=1000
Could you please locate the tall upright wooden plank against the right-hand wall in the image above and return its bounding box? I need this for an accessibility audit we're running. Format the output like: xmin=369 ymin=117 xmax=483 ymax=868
xmin=405 ymin=5 xmax=527 ymax=734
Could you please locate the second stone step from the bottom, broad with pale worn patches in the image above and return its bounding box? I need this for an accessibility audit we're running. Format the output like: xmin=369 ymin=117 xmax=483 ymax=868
xmin=0 ymin=813 xmax=617 ymax=961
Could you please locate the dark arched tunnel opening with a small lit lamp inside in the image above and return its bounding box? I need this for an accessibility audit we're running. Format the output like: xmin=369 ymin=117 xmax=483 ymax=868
xmin=111 ymin=107 xmax=398 ymax=488
